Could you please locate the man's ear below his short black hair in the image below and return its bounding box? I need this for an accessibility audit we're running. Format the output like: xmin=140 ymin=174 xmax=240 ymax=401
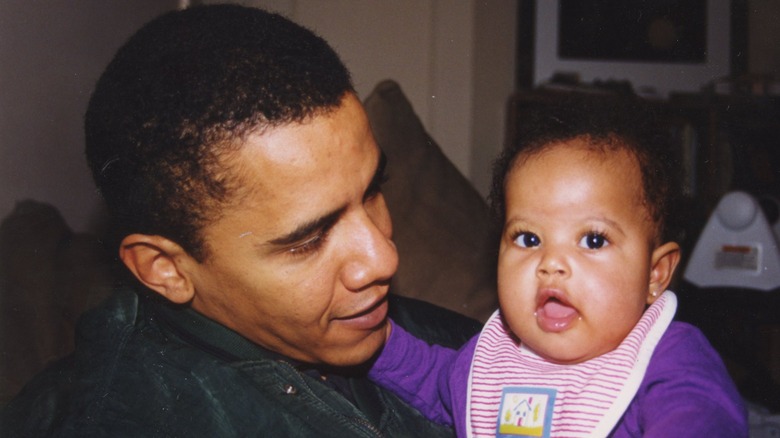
xmin=119 ymin=234 xmax=195 ymax=304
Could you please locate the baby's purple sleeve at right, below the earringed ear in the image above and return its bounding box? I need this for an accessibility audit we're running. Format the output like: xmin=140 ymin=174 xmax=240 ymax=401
xmin=614 ymin=322 xmax=748 ymax=438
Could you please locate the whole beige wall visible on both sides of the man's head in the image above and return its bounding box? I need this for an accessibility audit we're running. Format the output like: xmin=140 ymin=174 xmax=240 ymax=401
xmin=0 ymin=0 xmax=516 ymax=231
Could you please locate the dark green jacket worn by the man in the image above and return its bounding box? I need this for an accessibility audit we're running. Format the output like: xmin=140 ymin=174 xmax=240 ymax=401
xmin=0 ymin=290 xmax=479 ymax=438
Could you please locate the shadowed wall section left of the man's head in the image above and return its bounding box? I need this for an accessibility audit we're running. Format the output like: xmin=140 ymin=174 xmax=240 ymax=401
xmin=0 ymin=0 xmax=177 ymax=231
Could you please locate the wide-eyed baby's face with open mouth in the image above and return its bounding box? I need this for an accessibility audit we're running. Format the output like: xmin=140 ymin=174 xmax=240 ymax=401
xmin=498 ymin=139 xmax=663 ymax=363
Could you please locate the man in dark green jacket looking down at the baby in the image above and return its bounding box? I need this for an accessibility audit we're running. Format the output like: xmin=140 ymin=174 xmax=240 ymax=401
xmin=0 ymin=5 xmax=478 ymax=437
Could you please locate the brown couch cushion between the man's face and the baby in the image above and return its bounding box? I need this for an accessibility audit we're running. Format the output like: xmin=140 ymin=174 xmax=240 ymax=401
xmin=364 ymin=80 xmax=498 ymax=321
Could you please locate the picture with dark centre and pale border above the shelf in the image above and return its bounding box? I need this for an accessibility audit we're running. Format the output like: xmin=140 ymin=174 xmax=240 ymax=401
xmin=533 ymin=0 xmax=732 ymax=97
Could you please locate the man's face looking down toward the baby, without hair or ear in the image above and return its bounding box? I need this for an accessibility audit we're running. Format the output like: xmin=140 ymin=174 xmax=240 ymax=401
xmin=183 ymin=93 xmax=398 ymax=366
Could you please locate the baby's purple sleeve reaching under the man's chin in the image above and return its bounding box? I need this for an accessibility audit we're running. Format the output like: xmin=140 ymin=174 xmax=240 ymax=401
xmin=369 ymin=324 xmax=476 ymax=428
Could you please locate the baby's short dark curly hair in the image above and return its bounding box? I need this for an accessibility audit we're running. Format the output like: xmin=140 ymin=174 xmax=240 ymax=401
xmin=489 ymin=95 xmax=680 ymax=243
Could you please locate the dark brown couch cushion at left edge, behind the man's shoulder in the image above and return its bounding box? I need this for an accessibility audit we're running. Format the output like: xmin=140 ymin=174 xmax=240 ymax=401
xmin=0 ymin=200 xmax=111 ymax=406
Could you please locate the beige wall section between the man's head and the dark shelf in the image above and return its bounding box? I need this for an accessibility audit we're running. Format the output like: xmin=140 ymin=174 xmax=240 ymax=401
xmin=225 ymin=0 xmax=517 ymax=194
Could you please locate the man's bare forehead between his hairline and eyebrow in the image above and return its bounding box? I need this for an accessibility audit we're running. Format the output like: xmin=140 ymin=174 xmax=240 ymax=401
xmin=212 ymin=97 xmax=382 ymax=238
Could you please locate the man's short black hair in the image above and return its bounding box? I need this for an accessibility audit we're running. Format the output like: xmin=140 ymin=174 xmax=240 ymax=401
xmin=85 ymin=5 xmax=354 ymax=260
